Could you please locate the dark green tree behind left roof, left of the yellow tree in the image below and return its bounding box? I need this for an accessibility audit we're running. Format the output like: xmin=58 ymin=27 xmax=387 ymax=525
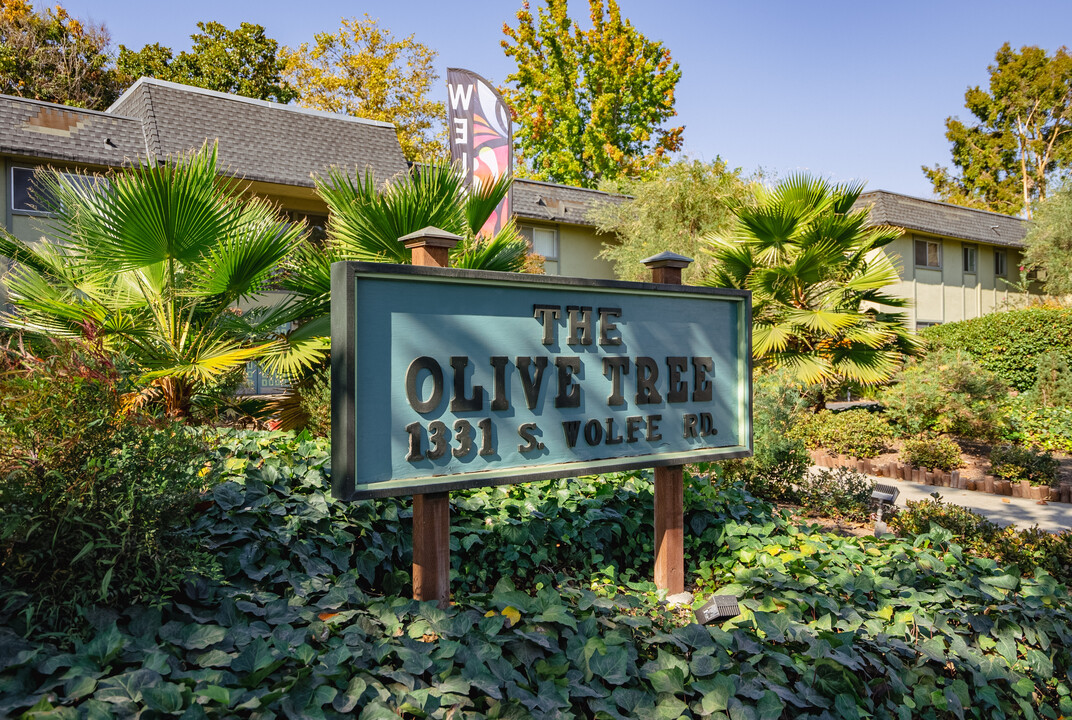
xmin=117 ymin=23 xmax=298 ymax=103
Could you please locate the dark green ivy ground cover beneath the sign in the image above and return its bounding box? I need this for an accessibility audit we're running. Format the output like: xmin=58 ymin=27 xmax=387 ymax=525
xmin=0 ymin=434 xmax=1072 ymax=720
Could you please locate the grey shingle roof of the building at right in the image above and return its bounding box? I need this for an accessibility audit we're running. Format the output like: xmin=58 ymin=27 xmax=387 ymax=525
xmin=853 ymin=190 xmax=1027 ymax=248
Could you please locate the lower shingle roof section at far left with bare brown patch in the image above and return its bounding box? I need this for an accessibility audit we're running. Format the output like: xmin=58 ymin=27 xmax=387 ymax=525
xmin=0 ymin=95 xmax=145 ymax=166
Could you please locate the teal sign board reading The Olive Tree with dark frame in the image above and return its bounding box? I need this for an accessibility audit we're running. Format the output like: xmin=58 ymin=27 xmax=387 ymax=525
xmin=331 ymin=263 xmax=751 ymax=499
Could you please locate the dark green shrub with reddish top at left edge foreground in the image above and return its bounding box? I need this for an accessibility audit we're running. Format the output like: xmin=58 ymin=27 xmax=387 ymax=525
xmin=0 ymin=340 xmax=212 ymax=630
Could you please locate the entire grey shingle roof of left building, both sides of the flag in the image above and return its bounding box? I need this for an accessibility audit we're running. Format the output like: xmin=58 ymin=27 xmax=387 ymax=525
xmin=0 ymin=77 xmax=629 ymax=226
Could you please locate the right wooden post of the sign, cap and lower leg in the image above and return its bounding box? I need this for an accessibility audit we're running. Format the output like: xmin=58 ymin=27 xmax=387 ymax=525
xmin=641 ymin=253 xmax=693 ymax=595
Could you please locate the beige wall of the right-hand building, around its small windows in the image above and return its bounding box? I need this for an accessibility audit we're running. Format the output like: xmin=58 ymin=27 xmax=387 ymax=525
xmin=885 ymin=233 xmax=1037 ymax=328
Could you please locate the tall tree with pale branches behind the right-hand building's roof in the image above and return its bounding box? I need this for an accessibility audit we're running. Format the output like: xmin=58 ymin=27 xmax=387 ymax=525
xmin=923 ymin=43 xmax=1072 ymax=218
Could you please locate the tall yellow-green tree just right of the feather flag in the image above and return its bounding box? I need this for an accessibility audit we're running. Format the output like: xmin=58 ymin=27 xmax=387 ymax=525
xmin=502 ymin=0 xmax=684 ymax=188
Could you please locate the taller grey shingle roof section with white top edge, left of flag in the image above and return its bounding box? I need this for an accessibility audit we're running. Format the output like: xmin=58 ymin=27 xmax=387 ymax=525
xmin=108 ymin=77 xmax=406 ymax=188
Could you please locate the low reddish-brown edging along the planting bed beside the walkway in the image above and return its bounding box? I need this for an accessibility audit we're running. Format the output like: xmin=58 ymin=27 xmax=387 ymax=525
xmin=808 ymin=449 xmax=1072 ymax=503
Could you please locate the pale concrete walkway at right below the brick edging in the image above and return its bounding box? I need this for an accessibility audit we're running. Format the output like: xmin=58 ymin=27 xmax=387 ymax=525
xmin=872 ymin=477 xmax=1072 ymax=533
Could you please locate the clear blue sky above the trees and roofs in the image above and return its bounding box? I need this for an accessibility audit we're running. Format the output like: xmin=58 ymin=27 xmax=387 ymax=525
xmin=64 ymin=0 xmax=1072 ymax=197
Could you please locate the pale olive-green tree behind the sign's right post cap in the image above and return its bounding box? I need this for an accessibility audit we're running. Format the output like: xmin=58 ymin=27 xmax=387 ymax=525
xmin=590 ymin=159 xmax=750 ymax=283
